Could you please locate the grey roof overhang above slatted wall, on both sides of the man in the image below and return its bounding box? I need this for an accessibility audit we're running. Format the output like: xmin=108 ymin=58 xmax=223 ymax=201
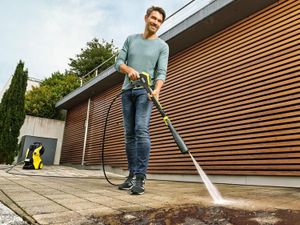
xmin=56 ymin=0 xmax=279 ymax=109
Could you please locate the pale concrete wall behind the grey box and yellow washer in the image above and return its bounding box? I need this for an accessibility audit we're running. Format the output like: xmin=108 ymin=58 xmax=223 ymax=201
xmin=19 ymin=115 xmax=65 ymax=165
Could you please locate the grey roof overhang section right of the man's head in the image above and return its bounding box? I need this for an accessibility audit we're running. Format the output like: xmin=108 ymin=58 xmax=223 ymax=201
xmin=160 ymin=0 xmax=278 ymax=56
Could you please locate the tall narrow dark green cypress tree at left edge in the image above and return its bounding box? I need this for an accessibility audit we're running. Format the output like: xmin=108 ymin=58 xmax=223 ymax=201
xmin=0 ymin=61 xmax=28 ymax=164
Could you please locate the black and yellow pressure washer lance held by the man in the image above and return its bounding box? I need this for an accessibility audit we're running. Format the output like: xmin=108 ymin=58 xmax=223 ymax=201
xmin=139 ymin=72 xmax=189 ymax=154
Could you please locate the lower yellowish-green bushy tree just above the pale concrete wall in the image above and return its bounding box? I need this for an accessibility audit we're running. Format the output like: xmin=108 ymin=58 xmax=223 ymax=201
xmin=25 ymin=72 xmax=80 ymax=119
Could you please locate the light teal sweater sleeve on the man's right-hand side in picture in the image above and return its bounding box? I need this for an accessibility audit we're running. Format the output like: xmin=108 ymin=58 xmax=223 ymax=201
xmin=155 ymin=43 xmax=169 ymax=81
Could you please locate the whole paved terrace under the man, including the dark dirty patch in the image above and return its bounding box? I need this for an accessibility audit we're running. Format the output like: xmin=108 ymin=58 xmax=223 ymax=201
xmin=0 ymin=166 xmax=300 ymax=225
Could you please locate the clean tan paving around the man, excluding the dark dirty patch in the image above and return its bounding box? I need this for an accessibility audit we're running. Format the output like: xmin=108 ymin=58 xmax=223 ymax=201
xmin=0 ymin=166 xmax=300 ymax=225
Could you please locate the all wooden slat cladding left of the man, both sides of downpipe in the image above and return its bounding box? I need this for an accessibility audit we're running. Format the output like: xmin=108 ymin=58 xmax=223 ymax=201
xmin=61 ymin=84 xmax=127 ymax=169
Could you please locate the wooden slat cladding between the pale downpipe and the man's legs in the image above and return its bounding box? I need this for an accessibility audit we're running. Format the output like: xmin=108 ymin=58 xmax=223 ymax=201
xmin=85 ymin=85 xmax=126 ymax=168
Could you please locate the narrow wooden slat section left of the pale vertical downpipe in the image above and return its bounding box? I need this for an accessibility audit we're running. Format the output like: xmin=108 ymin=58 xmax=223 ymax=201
xmin=60 ymin=102 xmax=87 ymax=164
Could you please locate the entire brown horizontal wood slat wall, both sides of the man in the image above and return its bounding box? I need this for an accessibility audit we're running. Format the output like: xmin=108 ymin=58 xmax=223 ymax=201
xmin=62 ymin=0 xmax=300 ymax=176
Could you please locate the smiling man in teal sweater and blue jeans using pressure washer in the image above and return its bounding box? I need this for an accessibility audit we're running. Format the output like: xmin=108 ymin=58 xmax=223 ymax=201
xmin=115 ymin=6 xmax=169 ymax=194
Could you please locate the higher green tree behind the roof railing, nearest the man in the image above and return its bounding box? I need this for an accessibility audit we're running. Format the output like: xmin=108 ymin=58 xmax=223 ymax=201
xmin=69 ymin=38 xmax=117 ymax=77
